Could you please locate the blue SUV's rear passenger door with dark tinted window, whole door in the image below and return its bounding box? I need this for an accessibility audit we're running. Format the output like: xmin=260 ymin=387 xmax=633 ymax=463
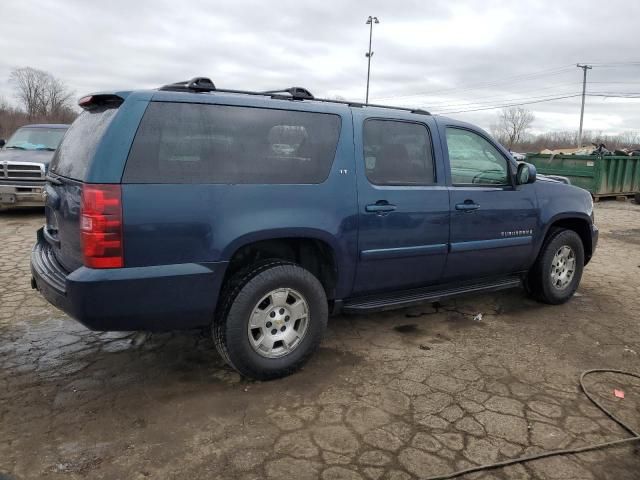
xmin=353 ymin=109 xmax=449 ymax=295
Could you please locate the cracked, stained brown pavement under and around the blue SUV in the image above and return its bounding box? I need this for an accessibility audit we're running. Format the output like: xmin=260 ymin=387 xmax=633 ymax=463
xmin=0 ymin=202 xmax=640 ymax=480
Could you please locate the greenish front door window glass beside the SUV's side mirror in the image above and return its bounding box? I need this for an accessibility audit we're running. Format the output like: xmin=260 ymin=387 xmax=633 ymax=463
xmin=447 ymin=128 xmax=510 ymax=185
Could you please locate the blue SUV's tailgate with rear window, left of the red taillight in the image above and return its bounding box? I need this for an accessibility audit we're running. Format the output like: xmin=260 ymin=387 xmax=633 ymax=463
xmin=44 ymin=106 xmax=117 ymax=271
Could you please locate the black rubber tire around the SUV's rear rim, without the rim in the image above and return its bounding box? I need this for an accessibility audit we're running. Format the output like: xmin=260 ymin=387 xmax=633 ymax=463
xmin=213 ymin=260 xmax=329 ymax=380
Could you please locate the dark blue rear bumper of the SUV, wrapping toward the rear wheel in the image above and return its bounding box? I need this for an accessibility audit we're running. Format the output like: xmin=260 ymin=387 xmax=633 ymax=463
xmin=31 ymin=229 xmax=226 ymax=331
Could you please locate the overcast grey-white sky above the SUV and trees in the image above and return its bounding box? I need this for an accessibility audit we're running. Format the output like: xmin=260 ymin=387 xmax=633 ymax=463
xmin=0 ymin=0 xmax=640 ymax=133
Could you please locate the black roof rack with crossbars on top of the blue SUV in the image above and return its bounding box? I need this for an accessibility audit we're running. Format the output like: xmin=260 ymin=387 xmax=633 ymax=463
xmin=160 ymin=77 xmax=431 ymax=115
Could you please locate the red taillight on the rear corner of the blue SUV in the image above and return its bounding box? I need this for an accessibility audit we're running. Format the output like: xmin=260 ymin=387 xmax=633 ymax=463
xmin=80 ymin=184 xmax=124 ymax=268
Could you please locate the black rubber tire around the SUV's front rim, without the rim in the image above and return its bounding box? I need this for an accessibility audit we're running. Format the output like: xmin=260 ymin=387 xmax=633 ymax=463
xmin=527 ymin=228 xmax=584 ymax=305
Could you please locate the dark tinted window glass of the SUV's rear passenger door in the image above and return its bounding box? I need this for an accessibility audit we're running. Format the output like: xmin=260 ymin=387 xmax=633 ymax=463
xmin=363 ymin=120 xmax=435 ymax=185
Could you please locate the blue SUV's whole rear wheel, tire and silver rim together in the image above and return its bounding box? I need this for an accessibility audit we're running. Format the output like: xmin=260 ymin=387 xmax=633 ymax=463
xmin=213 ymin=260 xmax=328 ymax=380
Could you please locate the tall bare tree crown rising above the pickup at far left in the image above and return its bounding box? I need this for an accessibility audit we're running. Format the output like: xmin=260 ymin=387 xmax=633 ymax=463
xmin=9 ymin=67 xmax=73 ymax=118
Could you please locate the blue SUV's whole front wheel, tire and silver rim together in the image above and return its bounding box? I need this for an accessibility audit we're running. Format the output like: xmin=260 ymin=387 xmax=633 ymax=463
xmin=527 ymin=229 xmax=584 ymax=305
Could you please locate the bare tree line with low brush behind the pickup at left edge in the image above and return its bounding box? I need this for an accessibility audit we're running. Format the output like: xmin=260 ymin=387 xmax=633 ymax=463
xmin=0 ymin=67 xmax=78 ymax=139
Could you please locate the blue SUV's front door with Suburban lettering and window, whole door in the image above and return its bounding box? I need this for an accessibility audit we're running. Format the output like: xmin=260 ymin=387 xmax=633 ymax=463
xmin=444 ymin=126 xmax=538 ymax=281
